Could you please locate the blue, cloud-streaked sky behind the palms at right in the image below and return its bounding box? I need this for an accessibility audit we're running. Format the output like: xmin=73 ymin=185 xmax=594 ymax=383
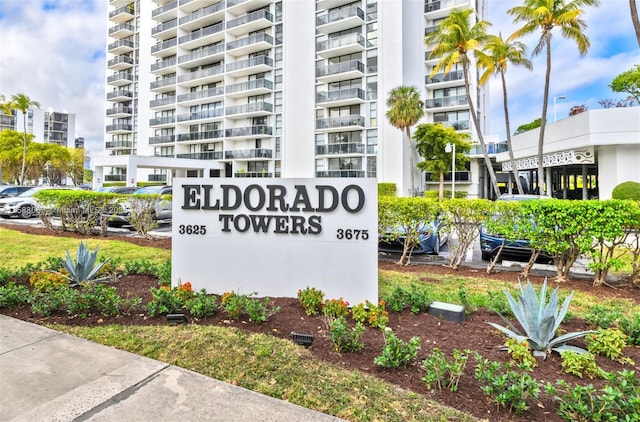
xmin=487 ymin=0 xmax=640 ymax=139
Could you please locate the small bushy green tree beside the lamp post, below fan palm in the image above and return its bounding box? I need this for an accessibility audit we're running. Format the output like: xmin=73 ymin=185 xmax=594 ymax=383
xmin=413 ymin=123 xmax=471 ymax=200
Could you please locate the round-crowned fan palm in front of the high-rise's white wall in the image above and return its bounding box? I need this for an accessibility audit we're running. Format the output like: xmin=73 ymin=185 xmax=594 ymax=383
xmin=386 ymin=85 xmax=424 ymax=196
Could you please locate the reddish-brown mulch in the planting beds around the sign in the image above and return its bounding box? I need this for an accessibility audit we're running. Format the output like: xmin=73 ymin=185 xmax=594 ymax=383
xmin=2 ymin=225 xmax=640 ymax=421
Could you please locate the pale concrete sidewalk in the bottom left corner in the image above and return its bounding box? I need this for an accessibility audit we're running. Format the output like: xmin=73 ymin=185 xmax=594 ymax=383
xmin=0 ymin=315 xmax=340 ymax=422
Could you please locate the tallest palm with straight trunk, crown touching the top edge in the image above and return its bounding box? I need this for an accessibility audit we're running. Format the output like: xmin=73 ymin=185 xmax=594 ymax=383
xmin=507 ymin=0 xmax=598 ymax=193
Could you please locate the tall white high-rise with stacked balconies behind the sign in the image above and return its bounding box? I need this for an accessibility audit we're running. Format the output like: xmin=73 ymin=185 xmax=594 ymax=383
xmin=94 ymin=0 xmax=486 ymax=196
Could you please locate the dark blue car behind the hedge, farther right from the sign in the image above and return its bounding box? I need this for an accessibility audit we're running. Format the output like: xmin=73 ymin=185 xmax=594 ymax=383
xmin=480 ymin=194 xmax=550 ymax=261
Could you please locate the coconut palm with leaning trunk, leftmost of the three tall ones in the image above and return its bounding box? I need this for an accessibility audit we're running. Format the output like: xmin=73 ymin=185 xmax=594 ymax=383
xmin=424 ymin=9 xmax=500 ymax=197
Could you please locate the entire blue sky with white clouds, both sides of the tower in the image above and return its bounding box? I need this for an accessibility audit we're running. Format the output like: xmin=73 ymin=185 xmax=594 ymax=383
xmin=0 ymin=0 xmax=640 ymax=162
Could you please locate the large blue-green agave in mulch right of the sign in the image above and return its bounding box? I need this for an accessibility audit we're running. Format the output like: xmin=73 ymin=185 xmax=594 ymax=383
xmin=488 ymin=278 xmax=593 ymax=358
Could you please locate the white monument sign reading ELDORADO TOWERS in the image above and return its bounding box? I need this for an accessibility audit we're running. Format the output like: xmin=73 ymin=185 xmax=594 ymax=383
xmin=172 ymin=178 xmax=378 ymax=305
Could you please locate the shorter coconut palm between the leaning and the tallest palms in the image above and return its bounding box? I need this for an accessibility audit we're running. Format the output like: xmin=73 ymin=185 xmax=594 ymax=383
xmin=476 ymin=34 xmax=533 ymax=193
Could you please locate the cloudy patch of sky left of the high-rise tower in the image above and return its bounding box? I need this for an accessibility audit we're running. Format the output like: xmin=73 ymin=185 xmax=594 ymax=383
xmin=0 ymin=0 xmax=108 ymax=157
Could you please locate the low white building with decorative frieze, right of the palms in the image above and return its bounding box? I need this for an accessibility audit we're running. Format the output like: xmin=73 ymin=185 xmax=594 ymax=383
xmin=497 ymin=107 xmax=640 ymax=199
